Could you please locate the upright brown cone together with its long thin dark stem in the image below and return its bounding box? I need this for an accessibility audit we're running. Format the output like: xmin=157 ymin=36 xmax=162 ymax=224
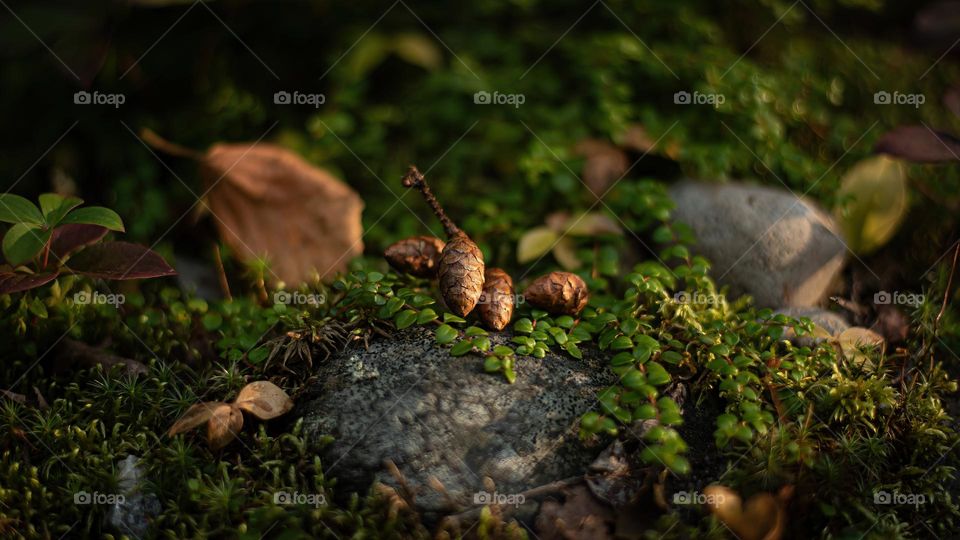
xmin=403 ymin=165 xmax=484 ymax=317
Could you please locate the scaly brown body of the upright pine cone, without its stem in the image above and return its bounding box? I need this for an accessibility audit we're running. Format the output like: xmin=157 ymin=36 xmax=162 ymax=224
xmin=439 ymin=231 xmax=483 ymax=317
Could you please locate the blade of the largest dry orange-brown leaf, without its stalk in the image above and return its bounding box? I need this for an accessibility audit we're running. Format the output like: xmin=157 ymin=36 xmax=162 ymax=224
xmin=200 ymin=143 xmax=363 ymax=285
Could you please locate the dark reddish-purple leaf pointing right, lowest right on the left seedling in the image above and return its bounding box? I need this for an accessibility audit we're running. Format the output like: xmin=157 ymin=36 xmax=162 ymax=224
xmin=69 ymin=242 xmax=177 ymax=279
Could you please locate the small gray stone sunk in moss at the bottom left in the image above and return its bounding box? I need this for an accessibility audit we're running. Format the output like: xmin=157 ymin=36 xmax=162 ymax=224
xmin=104 ymin=455 xmax=160 ymax=538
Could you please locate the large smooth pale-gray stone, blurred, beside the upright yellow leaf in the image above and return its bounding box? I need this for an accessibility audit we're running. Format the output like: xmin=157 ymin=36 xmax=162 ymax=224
xmin=670 ymin=180 xmax=847 ymax=308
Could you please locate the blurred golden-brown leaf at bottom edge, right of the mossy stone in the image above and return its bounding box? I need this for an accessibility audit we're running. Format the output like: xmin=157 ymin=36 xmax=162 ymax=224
xmin=703 ymin=485 xmax=793 ymax=540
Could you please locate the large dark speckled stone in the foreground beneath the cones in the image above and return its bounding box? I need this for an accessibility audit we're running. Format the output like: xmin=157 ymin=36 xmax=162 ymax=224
xmin=297 ymin=328 xmax=614 ymax=518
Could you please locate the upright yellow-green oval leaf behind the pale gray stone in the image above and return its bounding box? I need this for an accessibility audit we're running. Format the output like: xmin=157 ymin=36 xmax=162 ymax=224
xmin=834 ymin=155 xmax=907 ymax=253
